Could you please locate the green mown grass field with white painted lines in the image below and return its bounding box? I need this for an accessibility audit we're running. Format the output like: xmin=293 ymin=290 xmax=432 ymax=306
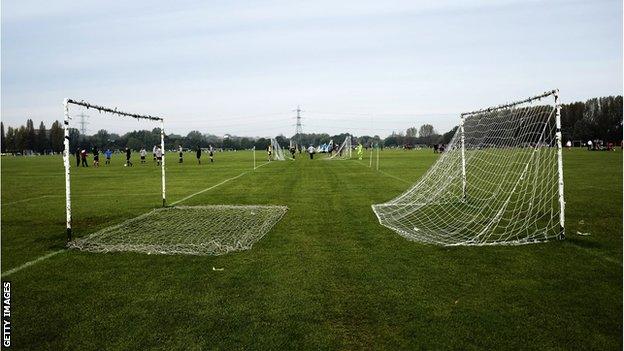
xmin=1 ymin=150 xmax=623 ymax=350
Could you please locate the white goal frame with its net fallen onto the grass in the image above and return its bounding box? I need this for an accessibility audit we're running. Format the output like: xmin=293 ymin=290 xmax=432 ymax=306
xmin=63 ymin=99 xmax=167 ymax=242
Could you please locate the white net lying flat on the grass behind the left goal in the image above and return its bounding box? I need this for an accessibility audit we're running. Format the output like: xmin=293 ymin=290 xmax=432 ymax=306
xmin=69 ymin=205 xmax=288 ymax=255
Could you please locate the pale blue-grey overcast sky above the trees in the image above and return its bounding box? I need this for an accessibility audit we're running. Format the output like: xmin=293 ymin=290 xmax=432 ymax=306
xmin=2 ymin=0 xmax=622 ymax=136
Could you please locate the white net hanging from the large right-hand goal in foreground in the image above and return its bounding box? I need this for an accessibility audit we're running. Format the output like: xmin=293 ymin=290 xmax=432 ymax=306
xmin=373 ymin=90 xmax=564 ymax=245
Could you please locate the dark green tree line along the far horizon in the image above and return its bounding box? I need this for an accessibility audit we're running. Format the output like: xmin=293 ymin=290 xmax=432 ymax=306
xmin=0 ymin=95 xmax=622 ymax=154
